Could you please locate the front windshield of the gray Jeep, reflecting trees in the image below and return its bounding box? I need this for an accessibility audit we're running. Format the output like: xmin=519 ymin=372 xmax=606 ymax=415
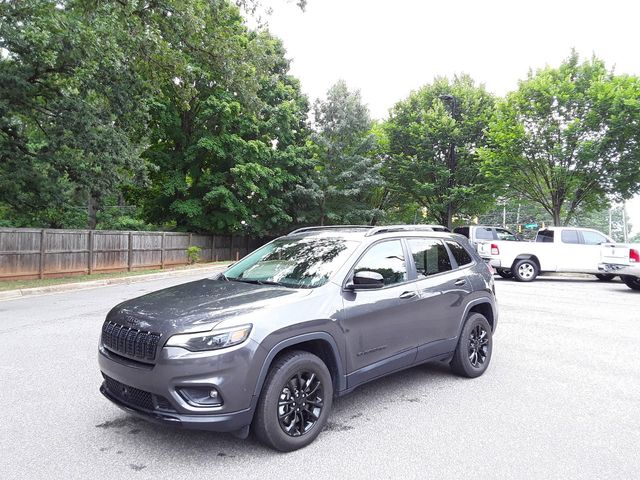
xmin=225 ymin=237 xmax=359 ymax=288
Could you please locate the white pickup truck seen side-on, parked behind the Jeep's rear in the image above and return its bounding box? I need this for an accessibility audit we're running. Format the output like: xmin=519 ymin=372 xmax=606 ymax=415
xmin=478 ymin=227 xmax=616 ymax=282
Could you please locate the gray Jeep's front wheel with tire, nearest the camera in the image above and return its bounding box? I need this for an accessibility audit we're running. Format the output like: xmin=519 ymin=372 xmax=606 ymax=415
xmin=253 ymin=350 xmax=333 ymax=452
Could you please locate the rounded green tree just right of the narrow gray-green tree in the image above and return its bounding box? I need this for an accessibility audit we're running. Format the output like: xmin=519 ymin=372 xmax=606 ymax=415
xmin=383 ymin=75 xmax=495 ymax=227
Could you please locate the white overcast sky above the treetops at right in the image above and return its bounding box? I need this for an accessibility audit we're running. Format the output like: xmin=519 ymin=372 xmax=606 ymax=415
xmin=263 ymin=0 xmax=640 ymax=231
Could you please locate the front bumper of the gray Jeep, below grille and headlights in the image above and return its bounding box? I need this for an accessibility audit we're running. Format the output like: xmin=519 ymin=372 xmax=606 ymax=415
xmin=98 ymin=340 xmax=261 ymax=432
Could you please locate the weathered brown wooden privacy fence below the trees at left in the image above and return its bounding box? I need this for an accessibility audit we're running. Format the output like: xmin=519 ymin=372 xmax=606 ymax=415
xmin=0 ymin=228 xmax=267 ymax=280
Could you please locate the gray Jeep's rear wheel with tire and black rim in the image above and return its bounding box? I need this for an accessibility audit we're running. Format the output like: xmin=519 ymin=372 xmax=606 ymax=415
xmin=450 ymin=313 xmax=493 ymax=378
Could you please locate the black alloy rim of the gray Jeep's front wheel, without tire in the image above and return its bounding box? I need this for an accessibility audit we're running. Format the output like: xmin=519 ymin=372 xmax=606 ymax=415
xmin=278 ymin=371 xmax=324 ymax=437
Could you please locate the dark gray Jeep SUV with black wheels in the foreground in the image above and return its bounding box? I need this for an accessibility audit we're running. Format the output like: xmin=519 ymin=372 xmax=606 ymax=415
xmin=99 ymin=226 xmax=498 ymax=451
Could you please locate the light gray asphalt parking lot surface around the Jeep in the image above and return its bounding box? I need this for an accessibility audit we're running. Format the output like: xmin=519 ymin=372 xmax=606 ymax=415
xmin=0 ymin=274 xmax=640 ymax=480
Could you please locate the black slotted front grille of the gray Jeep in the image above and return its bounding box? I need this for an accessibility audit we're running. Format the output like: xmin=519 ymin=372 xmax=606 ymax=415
xmin=102 ymin=322 xmax=160 ymax=360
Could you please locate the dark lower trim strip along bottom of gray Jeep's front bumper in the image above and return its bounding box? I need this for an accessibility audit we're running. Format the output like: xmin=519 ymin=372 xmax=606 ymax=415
xmin=100 ymin=384 xmax=253 ymax=432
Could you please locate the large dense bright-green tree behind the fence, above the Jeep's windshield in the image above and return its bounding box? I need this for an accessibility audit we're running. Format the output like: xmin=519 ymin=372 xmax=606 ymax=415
xmin=137 ymin=16 xmax=308 ymax=235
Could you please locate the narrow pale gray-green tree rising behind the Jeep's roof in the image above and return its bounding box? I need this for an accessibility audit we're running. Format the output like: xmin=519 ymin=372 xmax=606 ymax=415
xmin=308 ymin=80 xmax=383 ymax=225
